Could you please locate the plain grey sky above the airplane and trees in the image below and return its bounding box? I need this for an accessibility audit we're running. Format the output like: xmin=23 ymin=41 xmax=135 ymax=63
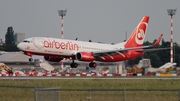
xmin=0 ymin=0 xmax=180 ymax=44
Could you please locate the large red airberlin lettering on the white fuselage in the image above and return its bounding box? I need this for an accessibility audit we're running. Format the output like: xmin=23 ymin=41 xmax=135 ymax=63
xmin=43 ymin=40 xmax=78 ymax=50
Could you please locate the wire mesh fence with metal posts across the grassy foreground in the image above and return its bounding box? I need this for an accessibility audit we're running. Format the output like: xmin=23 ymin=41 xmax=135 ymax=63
xmin=0 ymin=86 xmax=180 ymax=101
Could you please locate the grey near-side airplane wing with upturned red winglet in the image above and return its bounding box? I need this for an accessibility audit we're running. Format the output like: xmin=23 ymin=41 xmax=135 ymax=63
xmin=92 ymin=34 xmax=166 ymax=57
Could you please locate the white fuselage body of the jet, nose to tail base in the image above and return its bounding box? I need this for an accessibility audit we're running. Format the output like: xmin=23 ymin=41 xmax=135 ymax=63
xmin=18 ymin=37 xmax=124 ymax=56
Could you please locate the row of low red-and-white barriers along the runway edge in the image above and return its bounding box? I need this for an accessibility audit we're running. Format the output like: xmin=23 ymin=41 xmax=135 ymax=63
xmin=0 ymin=71 xmax=177 ymax=77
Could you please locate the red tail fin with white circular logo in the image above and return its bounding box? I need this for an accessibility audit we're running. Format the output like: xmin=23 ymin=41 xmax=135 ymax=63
xmin=124 ymin=16 xmax=149 ymax=48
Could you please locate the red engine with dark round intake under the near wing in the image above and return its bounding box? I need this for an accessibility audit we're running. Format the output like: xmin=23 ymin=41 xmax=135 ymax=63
xmin=76 ymin=52 xmax=94 ymax=61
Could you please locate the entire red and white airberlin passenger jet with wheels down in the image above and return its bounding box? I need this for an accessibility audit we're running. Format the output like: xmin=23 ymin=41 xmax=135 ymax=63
xmin=17 ymin=16 xmax=167 ymax=68
